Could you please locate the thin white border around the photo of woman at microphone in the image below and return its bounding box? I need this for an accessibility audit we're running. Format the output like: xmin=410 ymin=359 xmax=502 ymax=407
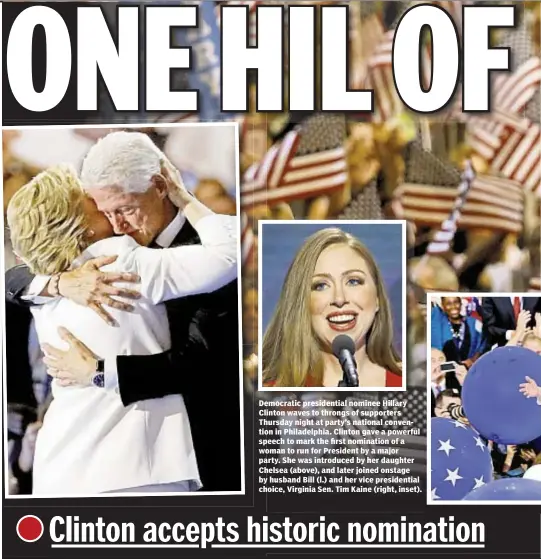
xmin=257 ymin=219 xmax=408 ymax=392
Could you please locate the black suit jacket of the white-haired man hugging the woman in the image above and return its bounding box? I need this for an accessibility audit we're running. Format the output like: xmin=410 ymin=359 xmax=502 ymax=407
xmin=6 ymin=222 xmax=241 ymax=491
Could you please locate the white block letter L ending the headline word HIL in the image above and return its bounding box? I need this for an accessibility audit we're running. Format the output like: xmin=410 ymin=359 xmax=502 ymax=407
xmin=321 ymin=6 xmax=374 ymax=112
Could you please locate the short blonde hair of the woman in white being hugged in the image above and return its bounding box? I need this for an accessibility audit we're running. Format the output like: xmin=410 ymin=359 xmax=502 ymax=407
xmin=7 ymin=166 xmax=87 ymax=275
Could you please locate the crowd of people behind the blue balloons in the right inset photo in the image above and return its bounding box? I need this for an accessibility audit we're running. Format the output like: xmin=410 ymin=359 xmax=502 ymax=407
xmin=430 ymin=295 xmax=541 ymax=478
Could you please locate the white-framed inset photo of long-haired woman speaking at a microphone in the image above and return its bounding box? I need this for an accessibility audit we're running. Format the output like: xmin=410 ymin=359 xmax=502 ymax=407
xmin=259 ymin=220 xmax=406 ymax=392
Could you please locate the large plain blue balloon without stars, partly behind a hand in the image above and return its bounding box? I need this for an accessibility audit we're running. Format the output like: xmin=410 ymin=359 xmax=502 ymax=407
xmin=462 ymin=346 xmax=541 ymax=444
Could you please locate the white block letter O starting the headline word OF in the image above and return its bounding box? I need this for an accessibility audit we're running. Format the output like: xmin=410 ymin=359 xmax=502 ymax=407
xmin=393 ymin=6 xmax=459 ymax=113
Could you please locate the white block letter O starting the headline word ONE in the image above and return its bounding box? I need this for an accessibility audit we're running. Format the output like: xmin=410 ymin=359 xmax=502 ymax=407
xmin=6 ymin=6 xmax=71 ymax=112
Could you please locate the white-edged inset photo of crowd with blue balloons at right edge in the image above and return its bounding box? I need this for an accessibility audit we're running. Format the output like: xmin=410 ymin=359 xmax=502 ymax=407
xmin=427 ymin=292 xmax=541 ymax=505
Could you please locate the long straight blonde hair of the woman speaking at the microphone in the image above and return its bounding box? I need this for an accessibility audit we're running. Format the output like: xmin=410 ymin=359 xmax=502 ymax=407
xmin=262 ymin=228 xmax=402 ymax=387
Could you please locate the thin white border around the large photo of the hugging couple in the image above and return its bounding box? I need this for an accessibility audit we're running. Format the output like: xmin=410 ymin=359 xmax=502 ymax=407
xmin=0 ymin=121 xmax=246 ymax=500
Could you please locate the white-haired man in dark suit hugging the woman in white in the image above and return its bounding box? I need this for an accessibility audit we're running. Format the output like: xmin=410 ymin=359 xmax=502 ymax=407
xmin=6 ymin=132 xmax=241 ymax=491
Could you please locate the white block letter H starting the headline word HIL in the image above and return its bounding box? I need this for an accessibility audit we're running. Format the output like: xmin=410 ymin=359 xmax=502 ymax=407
xmin=221 ymin=6 xmax=284 ymax=112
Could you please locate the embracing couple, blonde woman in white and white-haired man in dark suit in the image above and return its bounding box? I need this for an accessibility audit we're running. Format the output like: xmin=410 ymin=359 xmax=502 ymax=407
xmin=6 ymin=132 xmax=241 ymax=495
